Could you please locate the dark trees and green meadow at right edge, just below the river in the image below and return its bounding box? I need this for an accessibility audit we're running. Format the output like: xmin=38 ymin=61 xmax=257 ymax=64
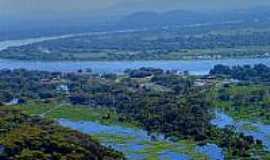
xmin=209 ymin=64 xmax=270 ymax=123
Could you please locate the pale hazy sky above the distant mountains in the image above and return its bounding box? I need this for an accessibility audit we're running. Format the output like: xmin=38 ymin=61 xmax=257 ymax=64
xmin=0 ymin=0 xmax=270 ymax=16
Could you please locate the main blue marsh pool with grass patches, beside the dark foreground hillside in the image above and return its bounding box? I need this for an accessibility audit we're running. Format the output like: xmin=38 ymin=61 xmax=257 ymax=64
xmin=58 ymin=119 xmax=190 ymax=160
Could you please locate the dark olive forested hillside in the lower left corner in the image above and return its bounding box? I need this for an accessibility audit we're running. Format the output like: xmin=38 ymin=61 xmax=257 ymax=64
xmin=0 ymin=106 xmax=124 ymax=160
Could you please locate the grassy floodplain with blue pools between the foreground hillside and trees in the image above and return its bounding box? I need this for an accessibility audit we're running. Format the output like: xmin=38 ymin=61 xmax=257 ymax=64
xmin=13 ymin=102 xmax=211 ymax=160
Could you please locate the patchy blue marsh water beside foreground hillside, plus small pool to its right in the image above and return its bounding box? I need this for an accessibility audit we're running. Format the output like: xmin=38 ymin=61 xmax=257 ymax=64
xmin=58 ymin=119 xmax=224 ymax=160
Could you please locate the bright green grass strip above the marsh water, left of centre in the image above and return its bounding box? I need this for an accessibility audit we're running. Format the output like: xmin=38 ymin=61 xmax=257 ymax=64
xmin=14 ymin=102 xmax=138 ymax=128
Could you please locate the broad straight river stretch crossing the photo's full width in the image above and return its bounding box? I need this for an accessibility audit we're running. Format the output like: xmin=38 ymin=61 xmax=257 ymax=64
xmin=0 ymin=58 xmax=270 ymax=75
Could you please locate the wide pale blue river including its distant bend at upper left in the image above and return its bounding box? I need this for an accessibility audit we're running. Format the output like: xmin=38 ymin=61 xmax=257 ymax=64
xmin=0 ymin=34 xmax=270 ymax=75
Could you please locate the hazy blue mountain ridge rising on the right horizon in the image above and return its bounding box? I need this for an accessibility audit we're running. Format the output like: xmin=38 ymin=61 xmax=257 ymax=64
xmin=117 ymin=8 xmax=270 ymax=28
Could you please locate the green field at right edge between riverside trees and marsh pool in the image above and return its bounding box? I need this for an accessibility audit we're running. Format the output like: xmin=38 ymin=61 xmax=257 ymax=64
xmin=209 ymin=84 xmax=270 ymax=124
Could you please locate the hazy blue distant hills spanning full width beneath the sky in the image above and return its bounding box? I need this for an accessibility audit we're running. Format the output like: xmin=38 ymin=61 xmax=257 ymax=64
xmin=0 ymin=7 xmax=270 ymax=40
